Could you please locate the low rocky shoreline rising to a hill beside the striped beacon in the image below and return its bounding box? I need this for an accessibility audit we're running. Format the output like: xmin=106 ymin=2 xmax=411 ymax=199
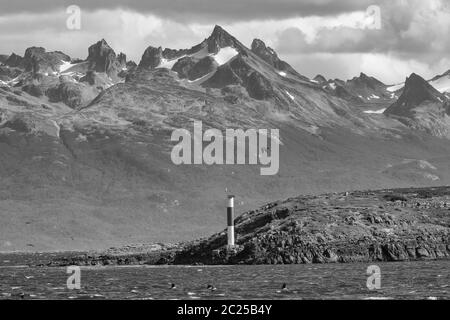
xmin=1 ymin=187 xmax=450 ymax=266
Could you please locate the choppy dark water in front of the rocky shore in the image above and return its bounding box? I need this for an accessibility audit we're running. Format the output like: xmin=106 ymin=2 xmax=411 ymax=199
xmin=0 ymin=261 xmax=450 ymax=300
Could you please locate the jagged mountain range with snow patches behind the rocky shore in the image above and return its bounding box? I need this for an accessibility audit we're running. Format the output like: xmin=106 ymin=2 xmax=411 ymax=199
xmin=0 ymin=26 xmax=450 ymax=251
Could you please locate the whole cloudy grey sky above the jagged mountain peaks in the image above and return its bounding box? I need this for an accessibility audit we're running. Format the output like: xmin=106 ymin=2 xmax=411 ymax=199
xmin=0 ymin=0 xmax=450 ymax=84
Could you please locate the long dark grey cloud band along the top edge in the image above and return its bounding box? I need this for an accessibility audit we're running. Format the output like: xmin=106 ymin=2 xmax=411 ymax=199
xmin=0 ymin=0 xmax=373 ymax=23
